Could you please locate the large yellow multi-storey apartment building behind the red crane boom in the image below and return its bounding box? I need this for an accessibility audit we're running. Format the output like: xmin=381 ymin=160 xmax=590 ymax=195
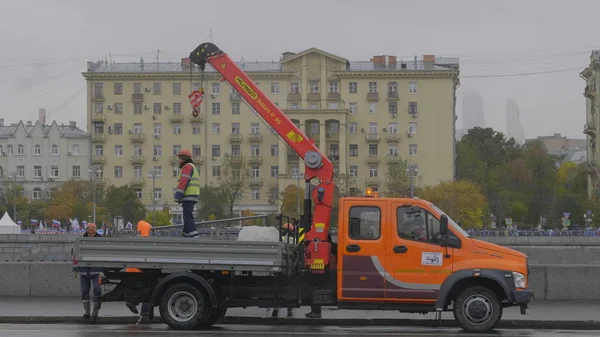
xmin=83 ymin=48 xmax=459 ymax=213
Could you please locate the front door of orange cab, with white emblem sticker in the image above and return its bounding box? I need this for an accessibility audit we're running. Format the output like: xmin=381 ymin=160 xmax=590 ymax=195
xmin=385 ymin=203 xmax=452 ymax=302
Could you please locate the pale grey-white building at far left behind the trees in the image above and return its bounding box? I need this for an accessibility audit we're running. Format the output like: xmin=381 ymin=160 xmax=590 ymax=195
xmin=0 ymin=118 xmax=90 ymax=200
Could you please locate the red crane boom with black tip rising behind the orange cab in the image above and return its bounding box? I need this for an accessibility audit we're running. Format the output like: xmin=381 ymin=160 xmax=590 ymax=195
xmin=190 ymin=42 xmax=334 ymax=273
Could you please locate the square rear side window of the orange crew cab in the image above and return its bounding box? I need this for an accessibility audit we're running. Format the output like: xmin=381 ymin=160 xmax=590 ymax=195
xmin=348 ymin=206 xmax=381 ymax=240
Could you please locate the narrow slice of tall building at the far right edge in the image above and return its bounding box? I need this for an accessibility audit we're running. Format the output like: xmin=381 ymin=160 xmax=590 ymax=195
xmin=579 ymin=50 xmax=600 ymax=197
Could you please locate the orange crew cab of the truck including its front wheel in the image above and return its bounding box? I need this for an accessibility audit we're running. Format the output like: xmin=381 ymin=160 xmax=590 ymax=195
xmin=336 ymin=191 xmax=533 ymax=331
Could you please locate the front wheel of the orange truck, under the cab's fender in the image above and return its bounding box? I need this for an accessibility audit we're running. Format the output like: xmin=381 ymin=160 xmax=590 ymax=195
xmin=453 ymin=286 xmax=502 ymax=332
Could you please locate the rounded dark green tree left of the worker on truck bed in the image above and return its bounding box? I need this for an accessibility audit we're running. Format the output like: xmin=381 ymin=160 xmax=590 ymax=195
xmin=104 ymin=185 xmax=146 ymax=223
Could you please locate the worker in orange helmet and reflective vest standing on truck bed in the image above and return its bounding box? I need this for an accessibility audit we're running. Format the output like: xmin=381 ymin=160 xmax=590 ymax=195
xmin=175 ymin=149 xmax=200 ymax=237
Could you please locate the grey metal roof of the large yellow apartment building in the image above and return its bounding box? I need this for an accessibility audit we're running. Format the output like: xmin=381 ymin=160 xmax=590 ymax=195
xmin=87 ymin=48 xmax=459 ymax=73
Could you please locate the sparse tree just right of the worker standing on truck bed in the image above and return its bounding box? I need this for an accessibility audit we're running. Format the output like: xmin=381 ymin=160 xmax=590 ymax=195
xmin=217 ymin=155 xmax=250 ymax=217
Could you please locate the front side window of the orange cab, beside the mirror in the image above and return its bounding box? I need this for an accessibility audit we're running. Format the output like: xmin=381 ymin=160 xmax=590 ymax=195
xmin=396 ymin=206 xmax=440 ymax=243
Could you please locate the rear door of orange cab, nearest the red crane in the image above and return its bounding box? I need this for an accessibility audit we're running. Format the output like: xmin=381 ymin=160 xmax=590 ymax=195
xmin=338 ymin=198 xmax=387 ymax=301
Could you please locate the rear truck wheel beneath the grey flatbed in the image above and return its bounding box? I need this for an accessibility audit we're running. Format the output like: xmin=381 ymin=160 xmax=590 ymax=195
xmin=159 ymin=283 xmax=210 ymax=330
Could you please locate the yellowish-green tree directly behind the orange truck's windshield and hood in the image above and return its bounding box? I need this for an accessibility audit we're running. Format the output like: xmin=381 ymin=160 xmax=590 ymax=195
xmin=420 ymin=180 xmax=489 ymax=228
